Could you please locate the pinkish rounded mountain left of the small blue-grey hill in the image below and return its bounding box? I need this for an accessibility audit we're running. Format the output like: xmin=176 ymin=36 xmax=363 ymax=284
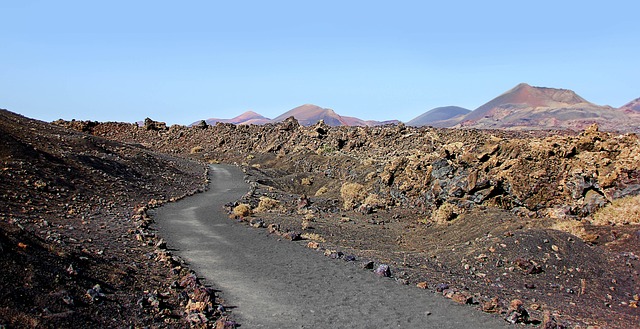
xmin=271 ymin=104 xmax=399 ymax=126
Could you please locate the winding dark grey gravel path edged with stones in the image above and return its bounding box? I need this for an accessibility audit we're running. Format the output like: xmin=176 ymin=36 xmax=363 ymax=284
xmin=154 ymin=165 xmax=507 ymax=328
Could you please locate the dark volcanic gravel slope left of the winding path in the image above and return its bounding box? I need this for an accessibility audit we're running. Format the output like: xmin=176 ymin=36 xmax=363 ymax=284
xmin=0 ymin=110 xmax=236 ymax=328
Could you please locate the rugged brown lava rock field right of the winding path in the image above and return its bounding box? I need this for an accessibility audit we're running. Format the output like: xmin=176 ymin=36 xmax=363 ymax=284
xmin=30 ymin=114 xmax=640 ymax=328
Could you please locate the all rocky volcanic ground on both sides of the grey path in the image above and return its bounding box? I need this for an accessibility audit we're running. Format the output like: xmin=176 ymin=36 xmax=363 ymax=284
xmin=0 ymin=112 xmax=640 ymax=328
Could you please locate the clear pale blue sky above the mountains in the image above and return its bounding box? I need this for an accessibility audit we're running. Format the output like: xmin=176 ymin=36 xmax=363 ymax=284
xmin=0 ymin=0 xmax=640 ymax=124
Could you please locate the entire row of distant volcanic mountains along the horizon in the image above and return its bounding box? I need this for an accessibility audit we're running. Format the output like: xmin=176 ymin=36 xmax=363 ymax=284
xmin=194 ymin=83 xmax=640 ymax=133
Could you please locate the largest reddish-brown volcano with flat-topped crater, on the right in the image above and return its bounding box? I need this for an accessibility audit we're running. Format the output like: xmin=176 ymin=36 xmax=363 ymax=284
xmin=454 ymin=83 xmax=640 ymax=132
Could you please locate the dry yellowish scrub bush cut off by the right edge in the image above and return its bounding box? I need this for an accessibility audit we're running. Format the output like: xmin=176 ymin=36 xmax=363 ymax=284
xmin=593 ymin=195 xmax=640 ymax=225
